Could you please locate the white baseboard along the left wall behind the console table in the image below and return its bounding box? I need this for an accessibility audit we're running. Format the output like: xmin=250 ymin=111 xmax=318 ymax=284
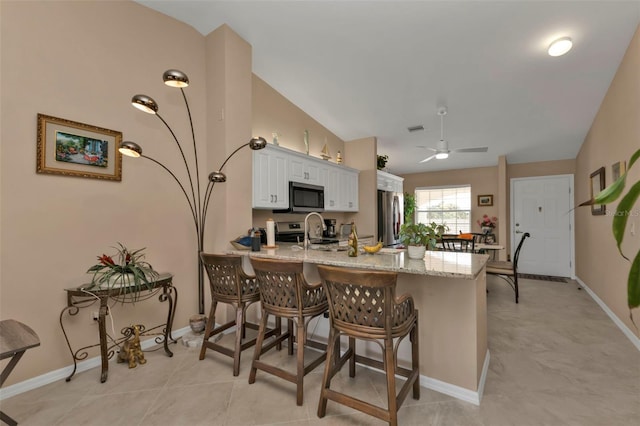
xmin=0 ymin=326 xmax=191 ymax=401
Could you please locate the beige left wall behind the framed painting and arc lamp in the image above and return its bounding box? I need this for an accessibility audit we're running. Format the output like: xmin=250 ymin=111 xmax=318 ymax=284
xmin=0 ymin=1 xmax=251 ymax=385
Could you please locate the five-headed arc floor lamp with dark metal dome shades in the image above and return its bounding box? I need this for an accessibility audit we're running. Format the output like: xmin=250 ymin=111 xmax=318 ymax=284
xmin=118 ymin=70 xmax=267 ymax=314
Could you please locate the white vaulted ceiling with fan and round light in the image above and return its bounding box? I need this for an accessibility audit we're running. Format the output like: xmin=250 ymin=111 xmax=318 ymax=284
xmin=138 ymin=0 xmax=640 ymax=174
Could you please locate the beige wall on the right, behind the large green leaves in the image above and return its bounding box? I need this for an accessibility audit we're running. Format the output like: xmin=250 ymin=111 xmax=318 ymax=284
xmin=575 ymin=27 xmax=640 ymax=336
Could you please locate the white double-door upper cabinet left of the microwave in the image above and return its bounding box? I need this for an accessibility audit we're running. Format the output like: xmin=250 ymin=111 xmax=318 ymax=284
xmin=252 ymin=146 xmax=289 ymax=209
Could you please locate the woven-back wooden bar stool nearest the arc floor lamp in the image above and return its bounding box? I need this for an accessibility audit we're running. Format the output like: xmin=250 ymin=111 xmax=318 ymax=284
xmin=200 ymin=253 xmax=281 ymax=376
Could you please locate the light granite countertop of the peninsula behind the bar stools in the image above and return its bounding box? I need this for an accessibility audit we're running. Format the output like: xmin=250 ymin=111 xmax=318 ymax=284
xmin=230 ymin=243 xmax=489 ymax=280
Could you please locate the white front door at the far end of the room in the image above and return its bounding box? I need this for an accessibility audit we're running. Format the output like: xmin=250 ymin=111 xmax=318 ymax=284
xmin=511 ymin=175 xmax=575 ymax=278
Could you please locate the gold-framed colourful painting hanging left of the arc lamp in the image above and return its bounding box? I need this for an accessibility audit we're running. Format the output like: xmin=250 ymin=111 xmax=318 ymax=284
xmin=36 ymin=114 xmax=122 ymax=181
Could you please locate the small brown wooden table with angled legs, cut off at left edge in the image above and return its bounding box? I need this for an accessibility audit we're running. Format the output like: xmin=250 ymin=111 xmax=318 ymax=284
xmin=0 ymin=320 xmax=40 ymax=426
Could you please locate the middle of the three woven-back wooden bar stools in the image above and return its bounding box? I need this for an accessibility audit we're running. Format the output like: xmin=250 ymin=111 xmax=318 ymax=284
xmin=249 ymin=258 xmax=327 ymax=405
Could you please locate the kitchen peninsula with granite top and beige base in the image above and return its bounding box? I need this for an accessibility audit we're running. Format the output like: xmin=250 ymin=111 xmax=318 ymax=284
xmin=232 ymin=244 xmax=489 ymax=405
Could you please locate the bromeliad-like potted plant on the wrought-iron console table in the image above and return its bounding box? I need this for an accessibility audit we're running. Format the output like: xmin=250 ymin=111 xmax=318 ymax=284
xmin=87 ymin=243 xmax=158 ymax=300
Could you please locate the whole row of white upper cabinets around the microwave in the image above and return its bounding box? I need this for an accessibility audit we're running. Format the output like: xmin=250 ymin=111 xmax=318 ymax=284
xmin=253 ymin=145 xmax=360 ymax=212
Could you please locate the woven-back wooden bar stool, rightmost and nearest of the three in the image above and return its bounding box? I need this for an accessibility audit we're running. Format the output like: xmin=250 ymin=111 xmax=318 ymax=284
xmin=318 ymin=265 xmax=420 ymax=425
